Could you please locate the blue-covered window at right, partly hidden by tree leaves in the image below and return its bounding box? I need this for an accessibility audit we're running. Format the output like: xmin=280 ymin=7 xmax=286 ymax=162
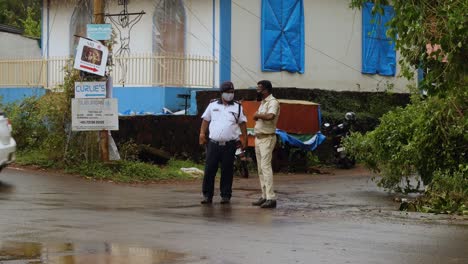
xmin=362 ymin=3 xmax=396 ymax=76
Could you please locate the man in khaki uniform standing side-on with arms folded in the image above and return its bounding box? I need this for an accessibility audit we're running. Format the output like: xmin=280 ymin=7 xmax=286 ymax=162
xmin=252 ymin=80 xmax=280 ymax=208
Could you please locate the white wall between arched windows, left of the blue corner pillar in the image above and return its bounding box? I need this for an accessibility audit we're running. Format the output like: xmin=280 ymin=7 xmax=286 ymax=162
xmin=42 ymin=0 xmax=219 ymax=83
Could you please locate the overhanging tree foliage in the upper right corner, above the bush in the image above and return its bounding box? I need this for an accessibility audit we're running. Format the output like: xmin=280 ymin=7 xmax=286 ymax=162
xmin=350 ymin=0 xmax=468 ymax=96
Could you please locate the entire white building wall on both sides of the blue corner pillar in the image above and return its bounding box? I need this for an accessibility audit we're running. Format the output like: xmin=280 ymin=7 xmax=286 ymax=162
xmin=43 ymin=0 xmax=414 ymax=92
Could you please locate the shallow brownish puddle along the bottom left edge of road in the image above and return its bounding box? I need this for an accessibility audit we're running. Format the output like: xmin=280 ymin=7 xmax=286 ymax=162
xmin=0 ymin=242 xmax=184 ymax=264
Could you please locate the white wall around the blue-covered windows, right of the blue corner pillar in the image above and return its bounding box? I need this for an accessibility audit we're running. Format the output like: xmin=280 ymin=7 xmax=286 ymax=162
xmin=231 ymin=0 xmax=414 ymax=92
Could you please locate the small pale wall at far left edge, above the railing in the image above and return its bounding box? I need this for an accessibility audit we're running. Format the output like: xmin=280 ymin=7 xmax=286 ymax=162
xmin=0 ymin=32 xmax=41 ymax=58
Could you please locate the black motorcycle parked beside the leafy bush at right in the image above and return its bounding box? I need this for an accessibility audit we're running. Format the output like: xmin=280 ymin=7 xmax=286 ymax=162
xmin=322 ymin=112 xmax=356 ymax=169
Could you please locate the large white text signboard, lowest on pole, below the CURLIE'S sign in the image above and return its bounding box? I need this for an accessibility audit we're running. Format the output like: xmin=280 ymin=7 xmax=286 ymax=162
xmin=72 ymin=98 xmax=119 ymax=131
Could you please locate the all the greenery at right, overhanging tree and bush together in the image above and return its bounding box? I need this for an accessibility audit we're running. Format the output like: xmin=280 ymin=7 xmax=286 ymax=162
xmin=346 ymin=0 xmax=468 ymax=212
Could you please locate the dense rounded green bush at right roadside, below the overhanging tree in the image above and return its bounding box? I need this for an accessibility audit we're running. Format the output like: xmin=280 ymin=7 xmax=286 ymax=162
xmin=345 ymin=92 xmax=468 ymax=190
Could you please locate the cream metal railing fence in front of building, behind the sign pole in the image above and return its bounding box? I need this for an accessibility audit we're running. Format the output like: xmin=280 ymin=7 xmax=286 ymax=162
xmin=0 ymin=54 xmax=217 ymax=89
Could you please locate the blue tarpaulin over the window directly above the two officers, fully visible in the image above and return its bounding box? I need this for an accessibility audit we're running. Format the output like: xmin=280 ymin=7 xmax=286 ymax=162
xmin=261 ymin=0 xmax=304 ymax=73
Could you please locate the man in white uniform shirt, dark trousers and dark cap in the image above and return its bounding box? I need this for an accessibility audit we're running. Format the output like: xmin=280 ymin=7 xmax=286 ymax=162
xmin=199 ymin=82 xmax=247 ymax=204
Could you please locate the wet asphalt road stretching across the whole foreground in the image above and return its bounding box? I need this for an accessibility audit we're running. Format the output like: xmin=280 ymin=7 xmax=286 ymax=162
xmin=0 ymin=169 xmax=468 ymax=264
